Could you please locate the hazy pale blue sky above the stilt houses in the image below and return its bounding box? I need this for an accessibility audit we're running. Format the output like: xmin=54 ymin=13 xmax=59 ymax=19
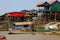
xmin=0 ymin=0 xmax=59 ymax=15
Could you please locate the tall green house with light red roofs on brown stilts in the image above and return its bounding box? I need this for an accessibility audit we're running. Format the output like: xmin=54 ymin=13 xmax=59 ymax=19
xmin=36 ymin=0 xmax=60 ymax=21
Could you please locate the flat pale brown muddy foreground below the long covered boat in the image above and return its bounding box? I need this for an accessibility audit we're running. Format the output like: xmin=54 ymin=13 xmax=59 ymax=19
xmin=0 ymin=32 xmax=60 ymax=40
